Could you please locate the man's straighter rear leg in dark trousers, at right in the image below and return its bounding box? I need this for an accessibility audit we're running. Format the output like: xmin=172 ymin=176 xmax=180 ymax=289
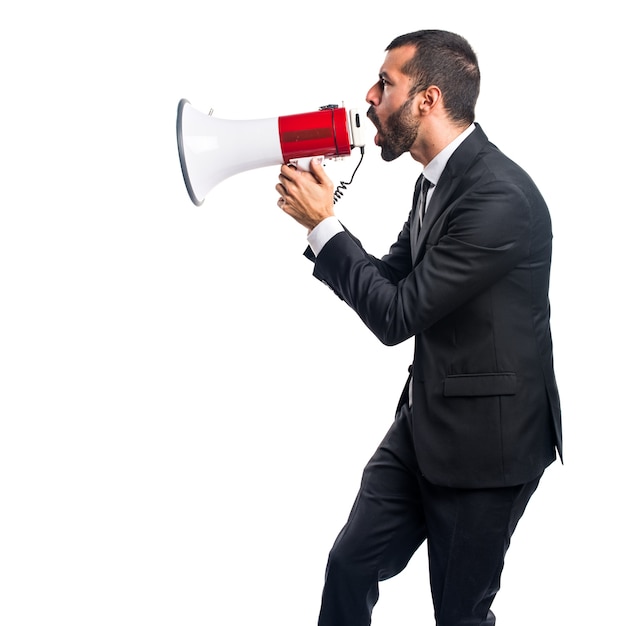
xmin=420 ymin=478 xmax=539 ymax=626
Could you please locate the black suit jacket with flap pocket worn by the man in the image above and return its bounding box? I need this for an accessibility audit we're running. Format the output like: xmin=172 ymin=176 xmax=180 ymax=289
xmin=314 ymin=125 xmax=562 ymax=488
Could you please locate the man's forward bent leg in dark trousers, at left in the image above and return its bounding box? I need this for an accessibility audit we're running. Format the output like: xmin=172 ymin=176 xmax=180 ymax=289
xmin=319 ymin=407 xmax=426 ymax=626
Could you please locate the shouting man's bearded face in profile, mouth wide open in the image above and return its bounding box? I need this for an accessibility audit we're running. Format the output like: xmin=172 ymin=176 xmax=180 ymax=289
xmin=366 ymin=46 xmax=420 ymax=161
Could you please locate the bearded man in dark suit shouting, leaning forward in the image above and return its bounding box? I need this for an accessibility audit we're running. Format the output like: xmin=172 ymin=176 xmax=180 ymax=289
xmin=276 ymin=30 xmax=562 ymax=626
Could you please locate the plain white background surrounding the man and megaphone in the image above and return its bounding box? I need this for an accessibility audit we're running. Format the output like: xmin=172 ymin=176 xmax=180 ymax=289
xmin=0 ymin=0 xmax=624 ymax=626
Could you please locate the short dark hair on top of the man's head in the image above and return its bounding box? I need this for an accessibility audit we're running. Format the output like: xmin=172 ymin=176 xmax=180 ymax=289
xmin=386 ymin=30 xmax=480 ymax=124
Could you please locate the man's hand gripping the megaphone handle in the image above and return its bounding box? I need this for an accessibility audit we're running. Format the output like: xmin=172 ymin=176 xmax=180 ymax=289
xmin=276 ymin=159 xmax=334 ymax=231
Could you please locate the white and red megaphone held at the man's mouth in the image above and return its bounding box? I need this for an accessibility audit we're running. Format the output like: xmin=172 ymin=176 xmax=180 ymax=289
xmin=176 ymin=99 xmax=365 ymax=206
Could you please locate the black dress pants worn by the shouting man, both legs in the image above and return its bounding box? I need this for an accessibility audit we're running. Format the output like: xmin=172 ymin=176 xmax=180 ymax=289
xmin=318 ymin=406 xmax=539 ymax=626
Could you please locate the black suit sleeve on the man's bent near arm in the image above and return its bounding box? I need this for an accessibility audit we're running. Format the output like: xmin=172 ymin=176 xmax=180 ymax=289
xmin=314 ymin=181 xmax=530 ymax=345
